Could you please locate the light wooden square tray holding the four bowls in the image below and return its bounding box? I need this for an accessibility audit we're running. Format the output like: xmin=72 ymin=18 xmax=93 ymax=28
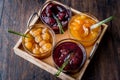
xmin=14 ymin=1 xmax=108 ymax=80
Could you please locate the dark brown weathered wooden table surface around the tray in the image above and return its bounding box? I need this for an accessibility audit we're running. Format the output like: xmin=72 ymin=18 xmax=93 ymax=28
xmin=0 ymin=0 xmax=120 ymax=80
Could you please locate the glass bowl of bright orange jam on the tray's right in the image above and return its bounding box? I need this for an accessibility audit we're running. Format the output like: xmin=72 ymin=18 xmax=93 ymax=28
xmin=69 ymin=15 xmax=101 ymax=46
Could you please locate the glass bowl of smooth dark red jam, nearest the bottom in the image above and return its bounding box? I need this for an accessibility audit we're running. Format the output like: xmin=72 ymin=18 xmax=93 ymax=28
xmin=52 ymin=39 xmax=86 ymax=73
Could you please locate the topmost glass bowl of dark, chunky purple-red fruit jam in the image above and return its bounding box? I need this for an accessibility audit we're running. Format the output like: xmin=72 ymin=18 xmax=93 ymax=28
xmin=40 ymin=0 xmax=71 ymax=34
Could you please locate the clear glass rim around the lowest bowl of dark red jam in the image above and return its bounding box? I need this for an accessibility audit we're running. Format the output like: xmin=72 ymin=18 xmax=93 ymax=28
xmin=52 ymin=38 xmax=87 ymax=73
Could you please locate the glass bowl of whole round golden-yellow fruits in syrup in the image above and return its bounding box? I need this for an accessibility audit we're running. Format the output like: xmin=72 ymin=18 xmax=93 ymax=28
xmin=22 ymin=24 xmax=55 ymax=59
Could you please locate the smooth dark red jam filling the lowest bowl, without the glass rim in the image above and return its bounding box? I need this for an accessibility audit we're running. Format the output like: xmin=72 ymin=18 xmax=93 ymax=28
xmin=53 ymin=42 xmax=85 ymax=72
